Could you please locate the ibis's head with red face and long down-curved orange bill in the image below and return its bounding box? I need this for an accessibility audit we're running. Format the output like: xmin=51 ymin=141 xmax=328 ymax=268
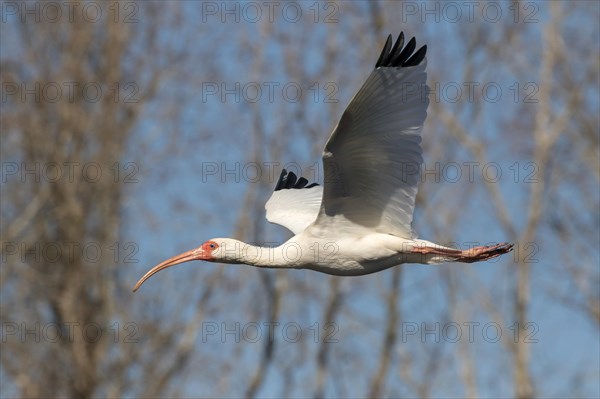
xmin=133 ymin=238 xmax=243 ymax=292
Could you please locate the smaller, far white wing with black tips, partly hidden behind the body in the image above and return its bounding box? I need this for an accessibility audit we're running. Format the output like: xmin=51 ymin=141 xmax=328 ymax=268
xmin=265 ymin=169 xmax=323 ymax=234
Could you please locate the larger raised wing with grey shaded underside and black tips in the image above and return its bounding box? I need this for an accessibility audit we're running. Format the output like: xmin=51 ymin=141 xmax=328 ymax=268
xmin=314 ymin=33 xmax=429 ymax=238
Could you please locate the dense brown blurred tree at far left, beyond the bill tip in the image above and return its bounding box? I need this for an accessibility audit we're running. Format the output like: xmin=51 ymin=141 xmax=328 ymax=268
xmin=0 ymin=2 xmax=216 ymax=398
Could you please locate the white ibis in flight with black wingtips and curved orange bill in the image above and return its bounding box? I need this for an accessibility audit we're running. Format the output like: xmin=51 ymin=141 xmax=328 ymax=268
xmin=133 ymin=33 xmax=513 ymax=291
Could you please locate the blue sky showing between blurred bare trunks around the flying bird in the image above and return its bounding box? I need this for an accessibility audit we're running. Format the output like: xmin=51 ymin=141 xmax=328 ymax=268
xmin=2 ymin=1 xmax=600 ymax=397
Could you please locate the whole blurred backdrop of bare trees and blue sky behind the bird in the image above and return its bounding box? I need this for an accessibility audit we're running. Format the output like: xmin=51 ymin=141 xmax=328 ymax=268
xmin=0 ymin=2 xmax=600 ymax=398
